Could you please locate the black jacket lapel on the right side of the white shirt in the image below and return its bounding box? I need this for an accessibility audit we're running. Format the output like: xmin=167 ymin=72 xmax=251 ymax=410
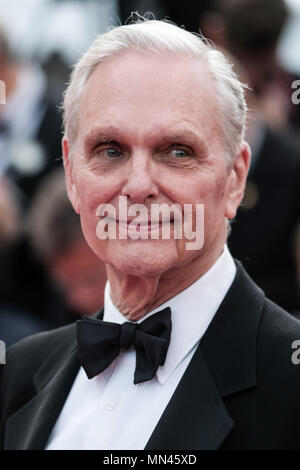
xmin=145 ymin=262 xmax=265 ymax=450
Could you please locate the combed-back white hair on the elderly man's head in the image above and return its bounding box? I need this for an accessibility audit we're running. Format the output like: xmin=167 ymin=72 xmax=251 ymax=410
xmin=63 ymin=15 xmax=247 ymax=162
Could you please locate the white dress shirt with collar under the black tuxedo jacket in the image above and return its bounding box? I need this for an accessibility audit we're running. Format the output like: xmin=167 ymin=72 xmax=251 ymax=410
xmin=45 ymin=245 xmax=236 ymax=450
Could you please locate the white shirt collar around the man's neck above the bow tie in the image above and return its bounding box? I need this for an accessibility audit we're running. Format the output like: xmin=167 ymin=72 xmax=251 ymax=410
xmin=103 ymin=245 xmax=236 ymax=384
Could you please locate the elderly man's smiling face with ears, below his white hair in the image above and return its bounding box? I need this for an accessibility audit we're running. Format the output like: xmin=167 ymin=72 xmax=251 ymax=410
xmin=64 ymin=52 xmax=247 ymax=276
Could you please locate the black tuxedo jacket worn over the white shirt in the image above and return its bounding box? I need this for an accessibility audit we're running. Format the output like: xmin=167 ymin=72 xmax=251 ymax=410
xmin=0 ymin=264 xmax=300 ymax=450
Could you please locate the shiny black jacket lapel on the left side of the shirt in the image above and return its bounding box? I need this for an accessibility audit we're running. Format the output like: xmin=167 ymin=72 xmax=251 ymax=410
xmin=4 ymin=324 xmax=80 ymax=450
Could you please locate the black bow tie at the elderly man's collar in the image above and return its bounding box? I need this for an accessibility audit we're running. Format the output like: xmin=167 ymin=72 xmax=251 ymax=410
xmin=77 ymin=307 xmax=171 ymax=384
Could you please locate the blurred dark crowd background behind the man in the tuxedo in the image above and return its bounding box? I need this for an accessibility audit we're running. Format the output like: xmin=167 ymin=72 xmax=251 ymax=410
xmin=0 ymin=0 xmax=300 ymax=345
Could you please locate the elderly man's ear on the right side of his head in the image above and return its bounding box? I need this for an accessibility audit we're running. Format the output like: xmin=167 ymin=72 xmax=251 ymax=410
xmin=225 ymin=142 xmax=251 ymax=219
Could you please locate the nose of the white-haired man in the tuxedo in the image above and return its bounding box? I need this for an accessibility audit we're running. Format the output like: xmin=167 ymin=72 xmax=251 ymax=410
xmin=122 ymin=152 xmax=159 ymax=204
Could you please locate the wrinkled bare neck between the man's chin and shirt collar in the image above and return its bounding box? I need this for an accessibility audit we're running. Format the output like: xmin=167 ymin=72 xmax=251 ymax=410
xmin=107 ymin=243 xmax=224 ymax=321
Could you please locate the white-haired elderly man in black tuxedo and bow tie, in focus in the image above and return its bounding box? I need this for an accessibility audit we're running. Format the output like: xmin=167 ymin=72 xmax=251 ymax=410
xmin=1 ymin=21 xmax=300 ymax=449
